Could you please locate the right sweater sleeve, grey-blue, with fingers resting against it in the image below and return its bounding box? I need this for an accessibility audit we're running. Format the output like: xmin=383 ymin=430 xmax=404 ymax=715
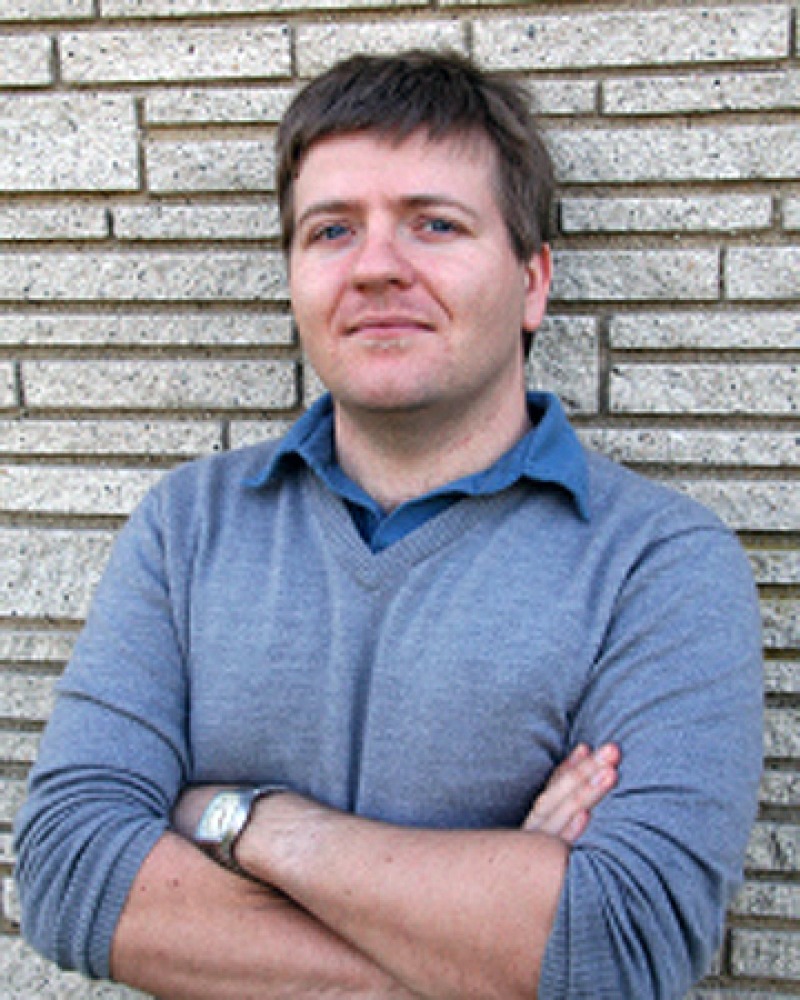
xmin=539 ymin=527 xmax=763 ymax=1000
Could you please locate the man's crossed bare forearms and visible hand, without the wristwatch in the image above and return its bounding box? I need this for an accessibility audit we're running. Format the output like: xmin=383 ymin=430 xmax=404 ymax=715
xmin=112 ymin=746 xmax=619 ymax=1000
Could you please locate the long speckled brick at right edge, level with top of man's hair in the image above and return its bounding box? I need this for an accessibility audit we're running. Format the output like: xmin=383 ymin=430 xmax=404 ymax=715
xmin=603 ymin=69 xmax=800 ymax=115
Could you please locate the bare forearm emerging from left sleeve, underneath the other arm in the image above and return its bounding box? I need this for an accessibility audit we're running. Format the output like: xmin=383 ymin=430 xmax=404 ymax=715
xmin=111 ymin=834 xmax=422 ymax=1000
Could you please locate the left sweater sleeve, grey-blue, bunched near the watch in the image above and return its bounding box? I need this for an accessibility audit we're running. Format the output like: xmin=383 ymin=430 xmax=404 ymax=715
xmin=15 ymin=494 xmax=189 ymax=978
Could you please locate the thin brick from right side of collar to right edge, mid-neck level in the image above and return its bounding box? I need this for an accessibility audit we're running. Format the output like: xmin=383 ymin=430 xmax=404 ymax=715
xmin=581 ymin=427 xmax=800 ymax=468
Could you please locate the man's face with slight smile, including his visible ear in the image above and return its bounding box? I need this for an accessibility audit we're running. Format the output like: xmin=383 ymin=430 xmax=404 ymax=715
xmin=289 ymin=133 xmax=550 ymax=419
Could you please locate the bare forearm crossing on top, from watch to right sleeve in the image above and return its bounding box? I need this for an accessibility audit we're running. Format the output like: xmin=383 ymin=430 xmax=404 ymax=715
xmin=237 ymin=795 xmax=568 ymax=1000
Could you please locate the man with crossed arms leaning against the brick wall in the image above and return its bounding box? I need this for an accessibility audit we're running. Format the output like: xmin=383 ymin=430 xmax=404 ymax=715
xmin=17 ymin=54 xmax=760 ymax=1000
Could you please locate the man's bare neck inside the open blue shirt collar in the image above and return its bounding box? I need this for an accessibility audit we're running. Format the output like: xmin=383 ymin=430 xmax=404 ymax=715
xmin=334 ymin=393 xmax=531 ymax=511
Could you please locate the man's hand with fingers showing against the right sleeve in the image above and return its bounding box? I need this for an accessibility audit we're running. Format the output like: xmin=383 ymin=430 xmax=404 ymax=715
xmin=522 ymin=743 xmax=621 ymax=845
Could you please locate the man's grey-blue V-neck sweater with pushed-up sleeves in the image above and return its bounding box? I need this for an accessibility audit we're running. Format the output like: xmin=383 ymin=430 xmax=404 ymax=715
xmin=17 ymin=444 xmax=761 ymax=1000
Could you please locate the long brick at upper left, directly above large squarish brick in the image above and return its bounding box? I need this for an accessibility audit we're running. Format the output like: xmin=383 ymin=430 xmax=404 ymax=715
xmin=60 ymin=25 xmax=291 ymax=84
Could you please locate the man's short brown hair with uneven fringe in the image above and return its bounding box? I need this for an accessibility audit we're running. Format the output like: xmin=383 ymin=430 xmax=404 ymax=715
xmin=277 ymin=51 xmax=554 ymax=262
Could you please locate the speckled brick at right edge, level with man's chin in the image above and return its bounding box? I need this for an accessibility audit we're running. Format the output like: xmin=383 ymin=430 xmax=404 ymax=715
xmin=609 ymin=363 xmax=800 ymax=416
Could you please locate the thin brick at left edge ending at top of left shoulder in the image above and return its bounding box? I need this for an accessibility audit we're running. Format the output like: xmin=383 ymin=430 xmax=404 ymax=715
xmin=0 ymin=465 xmax=163 ymax=517
